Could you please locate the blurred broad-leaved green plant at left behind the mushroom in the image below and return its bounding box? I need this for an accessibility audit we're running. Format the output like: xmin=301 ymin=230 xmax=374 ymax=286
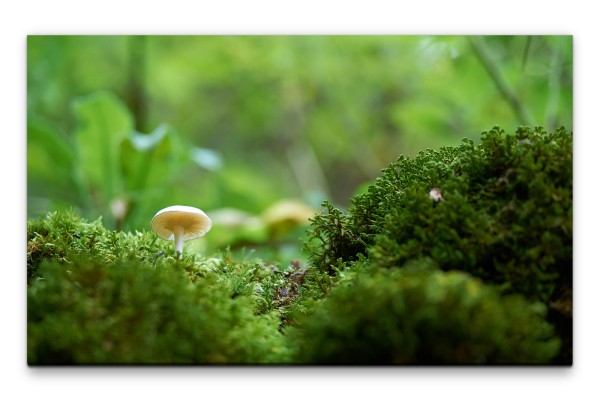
xmin=27 ymin=91 xmax=219 ymax=228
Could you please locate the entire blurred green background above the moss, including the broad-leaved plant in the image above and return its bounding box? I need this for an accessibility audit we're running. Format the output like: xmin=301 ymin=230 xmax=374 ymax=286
xmin=27 ymin=36 xmax=573 ymax=260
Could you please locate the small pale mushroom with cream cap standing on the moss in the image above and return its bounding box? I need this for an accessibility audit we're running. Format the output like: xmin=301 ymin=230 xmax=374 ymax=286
xmin=150 ymin=205 xmax=212 ymax=259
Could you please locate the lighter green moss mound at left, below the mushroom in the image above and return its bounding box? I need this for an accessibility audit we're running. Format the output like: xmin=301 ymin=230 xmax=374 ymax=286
xmin=27 ymin=212 xmax=289 ymax=365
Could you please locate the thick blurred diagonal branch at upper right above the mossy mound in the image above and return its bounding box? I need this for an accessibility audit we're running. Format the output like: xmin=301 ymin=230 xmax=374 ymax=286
xmin=468 ymin=36 xmax=531 ymax=125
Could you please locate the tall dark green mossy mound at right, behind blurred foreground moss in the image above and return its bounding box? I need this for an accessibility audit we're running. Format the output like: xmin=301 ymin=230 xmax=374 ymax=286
xmin=312 ymin=128 xmax=573 ymax=302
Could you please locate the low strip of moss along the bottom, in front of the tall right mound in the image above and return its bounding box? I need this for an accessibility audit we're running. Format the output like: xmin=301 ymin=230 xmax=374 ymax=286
xmin=27 ymin=195 xmax=559 ymax=365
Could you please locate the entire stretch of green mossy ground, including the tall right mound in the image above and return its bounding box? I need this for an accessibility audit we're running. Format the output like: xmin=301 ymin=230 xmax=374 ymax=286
xmin=27 ymin=129 xmax=572 ymax=365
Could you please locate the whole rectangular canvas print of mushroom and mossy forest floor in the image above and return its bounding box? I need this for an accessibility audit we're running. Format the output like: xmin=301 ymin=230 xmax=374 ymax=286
xmin=27 ymin=35 xmax=573 ymax=367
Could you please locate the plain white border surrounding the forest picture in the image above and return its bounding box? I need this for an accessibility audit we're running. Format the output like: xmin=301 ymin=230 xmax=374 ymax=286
xmin=0 ymin=0 xmax=600 ymax=401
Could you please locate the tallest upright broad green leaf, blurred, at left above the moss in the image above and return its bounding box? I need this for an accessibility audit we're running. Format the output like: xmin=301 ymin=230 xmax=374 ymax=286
xmin=73 ymin=92 xmax=133 ymax=203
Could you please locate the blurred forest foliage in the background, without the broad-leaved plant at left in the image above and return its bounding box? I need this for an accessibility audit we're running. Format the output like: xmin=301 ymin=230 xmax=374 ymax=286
xmin=27 ymin=35 xmax=573 ymax=212
